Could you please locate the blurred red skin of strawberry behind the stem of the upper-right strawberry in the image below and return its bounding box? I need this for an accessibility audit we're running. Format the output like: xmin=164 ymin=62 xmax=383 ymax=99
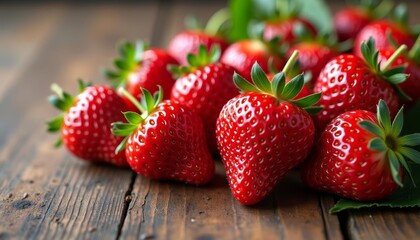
xmin=353 ymin=20 xmax=415 ymax=57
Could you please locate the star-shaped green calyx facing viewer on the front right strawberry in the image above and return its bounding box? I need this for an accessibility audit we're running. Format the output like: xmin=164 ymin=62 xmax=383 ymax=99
xmin=359 ymin=100 xmax=420 ymax=187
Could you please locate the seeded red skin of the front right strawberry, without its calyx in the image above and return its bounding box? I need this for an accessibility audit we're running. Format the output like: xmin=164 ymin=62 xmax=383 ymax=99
xmin=301 ymin=110 xmax=398 ymax=201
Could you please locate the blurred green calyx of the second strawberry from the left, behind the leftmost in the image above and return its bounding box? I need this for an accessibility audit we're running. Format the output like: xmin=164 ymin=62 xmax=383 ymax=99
xmin=103 ymin=41 xmax=148 ymax=89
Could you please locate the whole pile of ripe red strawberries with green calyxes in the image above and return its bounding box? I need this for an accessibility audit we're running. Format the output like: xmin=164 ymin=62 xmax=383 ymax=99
xmin=48 ymin=1 xmax=420 ymax=205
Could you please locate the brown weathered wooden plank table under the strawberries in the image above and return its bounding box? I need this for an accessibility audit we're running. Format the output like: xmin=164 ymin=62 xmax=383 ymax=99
xmin=0 ymin=1 xmax=420 ymax=240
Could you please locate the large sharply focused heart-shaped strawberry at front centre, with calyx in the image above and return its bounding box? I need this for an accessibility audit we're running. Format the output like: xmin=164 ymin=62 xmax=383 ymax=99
xmin=216 ymin=54 xmax=320 ymax=205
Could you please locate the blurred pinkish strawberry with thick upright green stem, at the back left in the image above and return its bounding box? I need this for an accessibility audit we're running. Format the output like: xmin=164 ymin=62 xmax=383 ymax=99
xmin=168 ymin=9 xmax=229 ymax=65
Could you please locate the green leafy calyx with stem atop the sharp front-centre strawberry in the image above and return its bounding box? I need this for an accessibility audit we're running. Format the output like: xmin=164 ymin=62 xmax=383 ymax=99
xmin=233 ymin=51 xmax=322 ymax=114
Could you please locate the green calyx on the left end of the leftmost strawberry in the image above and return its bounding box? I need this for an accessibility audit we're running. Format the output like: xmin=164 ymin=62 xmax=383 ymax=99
xmin=47 ymin=79 xmax=91 ymax=147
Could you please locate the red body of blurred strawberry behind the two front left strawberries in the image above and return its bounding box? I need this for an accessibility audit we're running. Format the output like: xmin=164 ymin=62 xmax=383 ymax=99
xmin=124 ymin=48 xmax=178 ymax=109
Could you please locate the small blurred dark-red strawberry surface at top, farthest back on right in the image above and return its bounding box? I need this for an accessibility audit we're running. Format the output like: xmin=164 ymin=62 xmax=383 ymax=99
xmin=333 ymin=7 xmax=372 ymax=41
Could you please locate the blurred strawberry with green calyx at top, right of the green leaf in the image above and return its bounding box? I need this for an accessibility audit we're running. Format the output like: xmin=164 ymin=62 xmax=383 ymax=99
xmin=263 ymin=1 xmax=317 ymax=43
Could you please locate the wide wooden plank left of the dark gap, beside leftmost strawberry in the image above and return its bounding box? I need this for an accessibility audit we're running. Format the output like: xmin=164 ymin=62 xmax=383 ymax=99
xmin=0 ymin=3 xmax=157 ymax=239
